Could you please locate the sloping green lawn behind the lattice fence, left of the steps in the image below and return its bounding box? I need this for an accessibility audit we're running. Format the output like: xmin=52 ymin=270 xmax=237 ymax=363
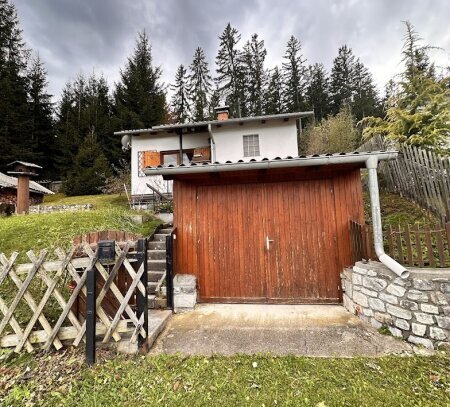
xmin=0 ymin=194 xmax=160 ymax=259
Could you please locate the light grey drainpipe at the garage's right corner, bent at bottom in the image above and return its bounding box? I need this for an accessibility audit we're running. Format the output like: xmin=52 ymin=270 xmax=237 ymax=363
xmin=366 ymin=155 xmax=409 ymax=278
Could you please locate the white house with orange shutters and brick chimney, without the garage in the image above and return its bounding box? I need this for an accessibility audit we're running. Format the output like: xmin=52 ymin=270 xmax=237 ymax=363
xmin=115 ymin=106 xmax=313 ymax=200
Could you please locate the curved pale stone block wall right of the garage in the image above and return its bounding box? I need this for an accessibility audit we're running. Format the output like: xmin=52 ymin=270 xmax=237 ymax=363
xmin=341 ymin=262 xmax=450 ymax=349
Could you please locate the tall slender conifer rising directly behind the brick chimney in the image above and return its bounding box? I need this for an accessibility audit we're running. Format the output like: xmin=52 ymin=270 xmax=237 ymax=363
xmin=216 ymin=23 xmax=243 ymax=117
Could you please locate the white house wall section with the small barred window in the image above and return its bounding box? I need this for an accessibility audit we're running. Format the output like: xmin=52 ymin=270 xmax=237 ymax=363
xmin=211 ymin=120 xmax=298 ymax=162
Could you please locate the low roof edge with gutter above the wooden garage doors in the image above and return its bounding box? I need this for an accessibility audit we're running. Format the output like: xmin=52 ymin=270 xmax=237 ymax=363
xmin=144 ymin=150 xmax=398 ymax=175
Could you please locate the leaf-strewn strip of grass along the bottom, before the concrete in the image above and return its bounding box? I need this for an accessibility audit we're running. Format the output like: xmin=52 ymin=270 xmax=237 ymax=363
xmin=0 ymin=352 xmax=450 ymax=407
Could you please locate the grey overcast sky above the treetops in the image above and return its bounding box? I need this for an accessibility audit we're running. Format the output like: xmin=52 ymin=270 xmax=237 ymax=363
xmin=12 ymin=0 xmax=450 ymax=99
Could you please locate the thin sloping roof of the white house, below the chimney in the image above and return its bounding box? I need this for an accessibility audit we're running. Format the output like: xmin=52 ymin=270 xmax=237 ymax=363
xmin=114 ymin=111 xmax=314 ymax=136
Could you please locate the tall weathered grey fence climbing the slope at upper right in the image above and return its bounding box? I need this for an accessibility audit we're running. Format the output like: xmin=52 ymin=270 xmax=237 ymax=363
xmin=358 ymin=136 xmax=450 ymax=223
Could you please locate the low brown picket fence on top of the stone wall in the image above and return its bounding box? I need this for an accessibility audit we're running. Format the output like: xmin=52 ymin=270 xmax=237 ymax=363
xmin=350 ymin=221 xmax=450 ymax=267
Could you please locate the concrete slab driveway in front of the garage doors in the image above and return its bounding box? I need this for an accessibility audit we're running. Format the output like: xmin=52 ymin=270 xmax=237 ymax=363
xmin=150 ymin=304 xmax=413 ymax=357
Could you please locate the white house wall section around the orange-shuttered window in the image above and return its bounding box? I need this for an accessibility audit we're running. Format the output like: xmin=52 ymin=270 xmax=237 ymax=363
xmin=131 ymin=133 xmax=210 ymax=196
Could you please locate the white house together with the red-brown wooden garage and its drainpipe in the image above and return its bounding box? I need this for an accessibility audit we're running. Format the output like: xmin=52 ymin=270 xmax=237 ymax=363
xmin=117 ymin=109 xmax=407 ymax=304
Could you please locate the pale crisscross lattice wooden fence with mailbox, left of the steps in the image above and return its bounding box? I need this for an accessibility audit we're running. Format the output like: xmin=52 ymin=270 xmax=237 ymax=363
xmin=0 ymin=239 xmax=147 ymax=352
